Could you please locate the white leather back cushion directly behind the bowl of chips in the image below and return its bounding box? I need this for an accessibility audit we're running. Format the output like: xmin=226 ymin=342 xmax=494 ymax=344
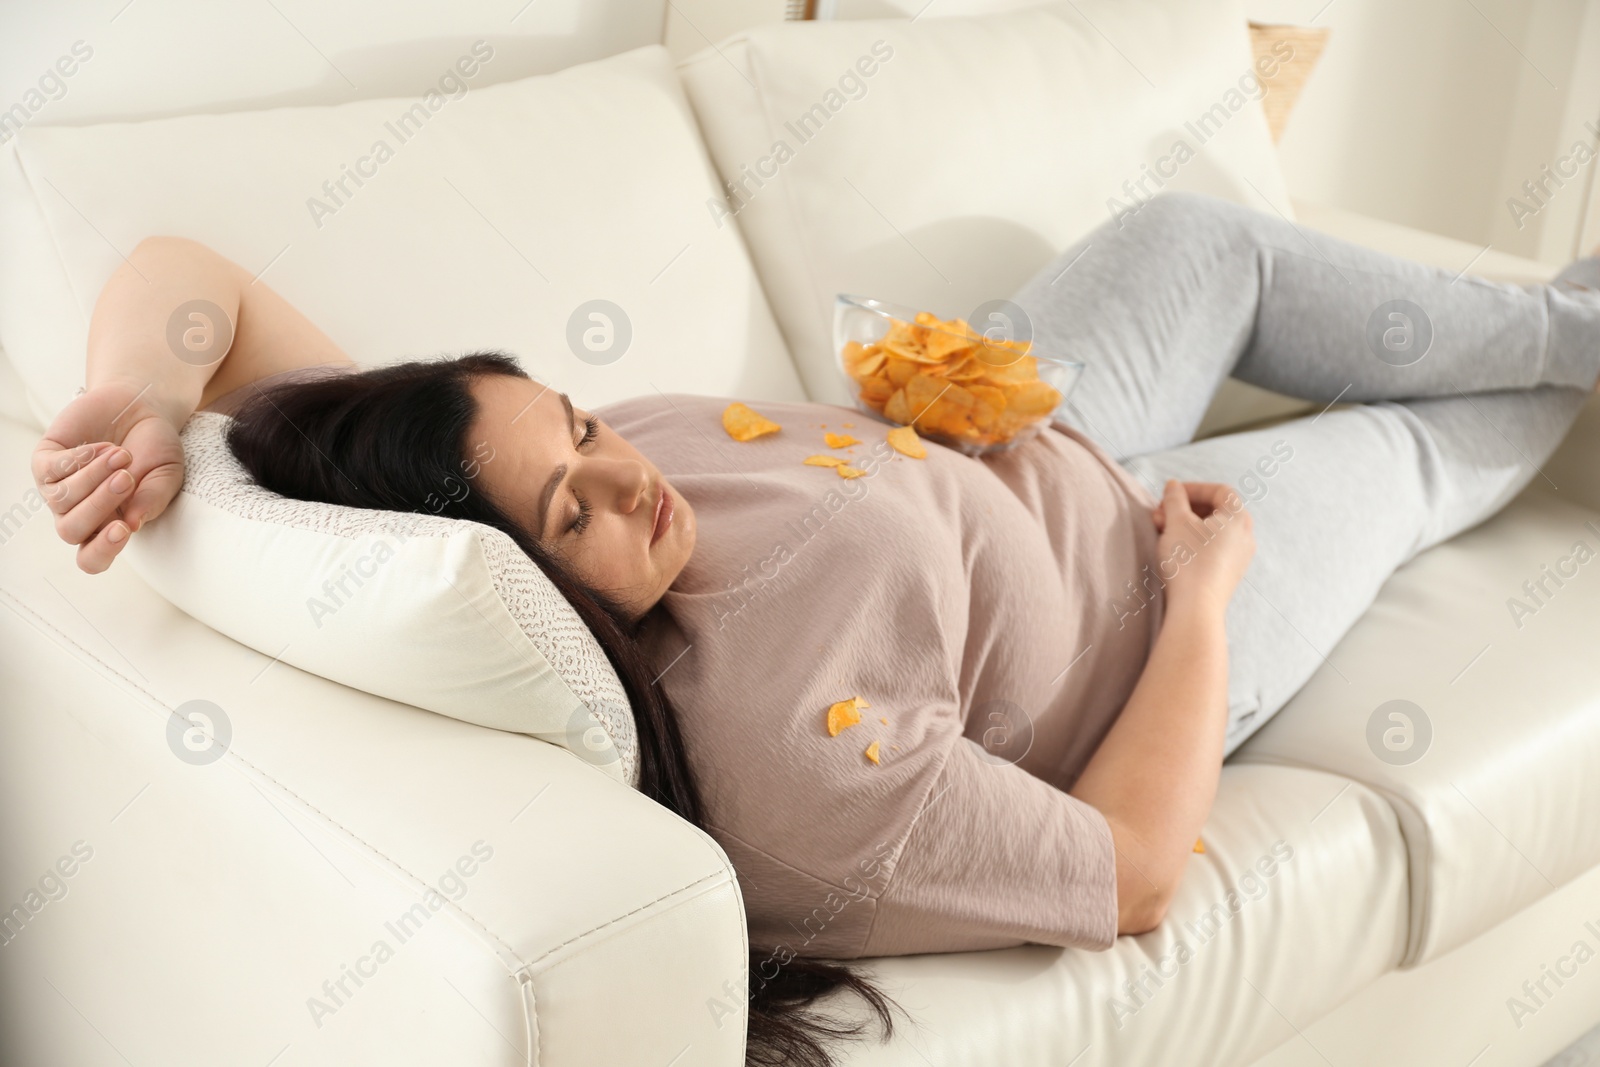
xmin=678 ymin=0 xmax=1291 ymax=403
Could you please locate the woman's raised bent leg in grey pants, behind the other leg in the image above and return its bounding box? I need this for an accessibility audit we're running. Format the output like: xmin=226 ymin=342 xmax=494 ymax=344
xmin=1013 ymin=194 xmax=1600 ymax=459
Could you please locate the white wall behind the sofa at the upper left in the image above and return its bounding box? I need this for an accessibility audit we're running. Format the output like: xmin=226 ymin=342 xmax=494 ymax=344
xmin=0 ymin=0 xmax=666 ymax=123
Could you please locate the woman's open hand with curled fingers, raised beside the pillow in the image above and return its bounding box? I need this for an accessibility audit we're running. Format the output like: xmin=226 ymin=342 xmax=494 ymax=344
xmin=34 ymin=379 xmax=184 ymax=574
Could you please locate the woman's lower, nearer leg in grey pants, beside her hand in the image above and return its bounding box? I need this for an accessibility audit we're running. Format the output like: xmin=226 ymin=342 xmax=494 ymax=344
xmin=1125 ymin=383 xmax=1600 ymax=753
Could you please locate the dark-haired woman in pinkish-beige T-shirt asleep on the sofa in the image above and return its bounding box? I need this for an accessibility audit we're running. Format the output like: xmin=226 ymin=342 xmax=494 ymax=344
xmin=35 ymin=195 xmax=1600 ymax=1062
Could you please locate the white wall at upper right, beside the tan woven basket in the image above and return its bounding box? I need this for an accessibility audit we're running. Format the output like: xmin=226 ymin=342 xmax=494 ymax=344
xmin=1246 ymin=0 xmax=1600 ymax=262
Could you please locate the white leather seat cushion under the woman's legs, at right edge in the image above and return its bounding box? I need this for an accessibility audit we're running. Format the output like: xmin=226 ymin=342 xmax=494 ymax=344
xmin=1235 ymin=489 xmax=1600 ymax=965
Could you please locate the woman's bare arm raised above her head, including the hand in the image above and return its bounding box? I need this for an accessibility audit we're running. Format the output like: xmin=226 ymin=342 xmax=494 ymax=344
xmin=34 ymin=237 xmax=350 ymax=574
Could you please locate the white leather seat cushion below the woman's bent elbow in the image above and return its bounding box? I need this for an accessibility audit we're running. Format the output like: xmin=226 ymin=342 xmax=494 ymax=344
xmin=845 ymin=766 xmax=1406 ymax=1067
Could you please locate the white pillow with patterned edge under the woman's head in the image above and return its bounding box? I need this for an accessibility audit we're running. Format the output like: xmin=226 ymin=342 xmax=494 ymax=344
xmin=125 ymin=411 xmax=638 ymax=785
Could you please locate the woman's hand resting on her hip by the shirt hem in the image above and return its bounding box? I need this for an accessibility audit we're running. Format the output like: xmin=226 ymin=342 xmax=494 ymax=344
xmin=1154 ymin=480 xmax=1256 ymax=614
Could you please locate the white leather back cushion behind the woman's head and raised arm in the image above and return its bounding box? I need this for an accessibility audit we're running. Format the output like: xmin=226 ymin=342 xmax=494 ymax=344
xmin=0 ymin=42 xmax=802 ymax=414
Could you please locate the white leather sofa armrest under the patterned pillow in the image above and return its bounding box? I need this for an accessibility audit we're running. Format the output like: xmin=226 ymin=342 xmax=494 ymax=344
xmin=0 ymin=421 xmax=747 ymax=1067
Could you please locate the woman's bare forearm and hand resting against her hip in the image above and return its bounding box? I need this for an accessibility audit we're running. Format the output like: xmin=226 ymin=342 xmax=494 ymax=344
xmin=1070 ymin=482 xmax=1254 ymax=934
